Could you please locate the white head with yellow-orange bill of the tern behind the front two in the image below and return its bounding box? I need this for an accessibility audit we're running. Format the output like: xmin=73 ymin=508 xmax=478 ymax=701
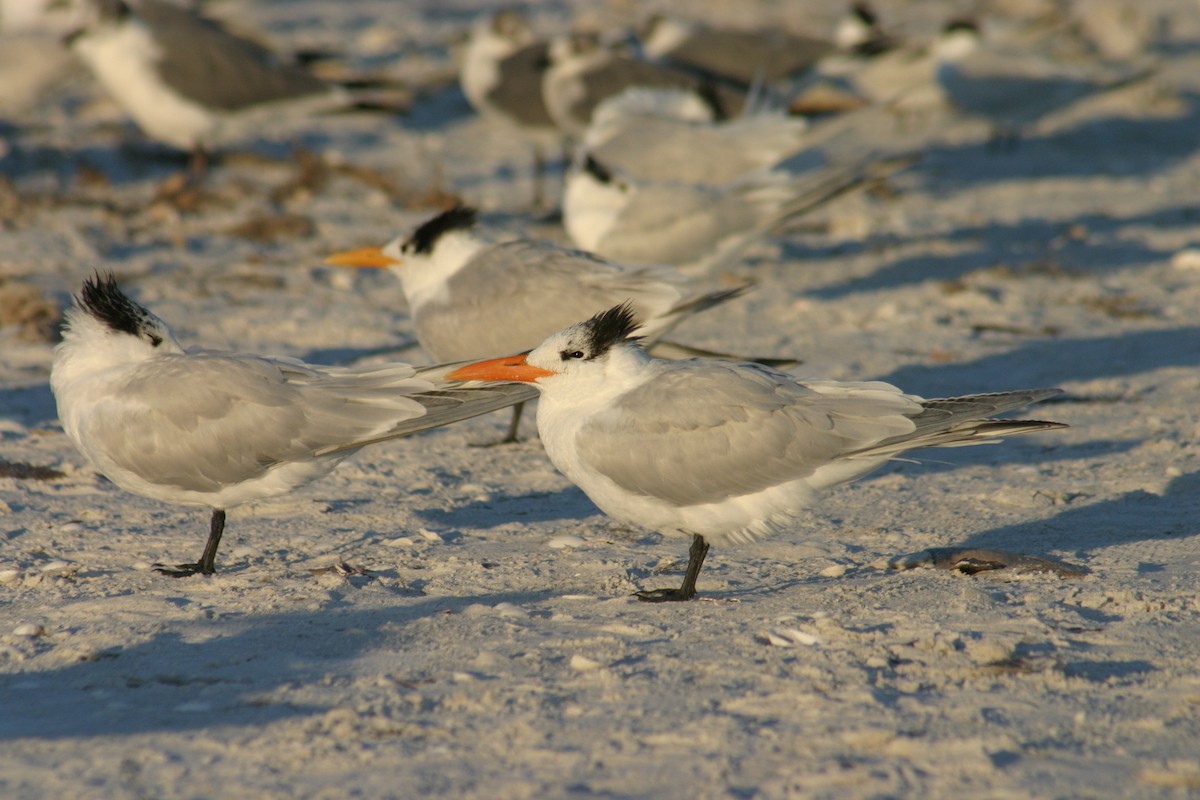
xmin=325 ymin=205 xmax=491 ymax=306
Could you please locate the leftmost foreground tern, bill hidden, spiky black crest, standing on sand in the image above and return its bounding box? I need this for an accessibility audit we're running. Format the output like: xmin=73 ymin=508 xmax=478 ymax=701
xmin=50 ymin=275 xmax=536 ymax=577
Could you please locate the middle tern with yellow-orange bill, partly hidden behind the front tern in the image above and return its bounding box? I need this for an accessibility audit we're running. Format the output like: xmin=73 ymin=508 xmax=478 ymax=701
xmin=326 ymin=206 xmax=768 ymax=441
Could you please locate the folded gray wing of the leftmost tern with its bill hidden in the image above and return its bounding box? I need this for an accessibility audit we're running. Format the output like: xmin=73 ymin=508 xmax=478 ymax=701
xmin=83 ymin=353 xmax=433 ymax=492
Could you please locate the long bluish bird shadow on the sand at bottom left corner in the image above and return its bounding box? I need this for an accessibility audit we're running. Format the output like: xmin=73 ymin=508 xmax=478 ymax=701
xmin=0 ymin=591 xmax=554 ymax=740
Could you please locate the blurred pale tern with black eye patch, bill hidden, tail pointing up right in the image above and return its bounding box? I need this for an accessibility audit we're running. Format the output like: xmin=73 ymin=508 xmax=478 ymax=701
xmin=563 ymin=154 xmax=912 ymax=271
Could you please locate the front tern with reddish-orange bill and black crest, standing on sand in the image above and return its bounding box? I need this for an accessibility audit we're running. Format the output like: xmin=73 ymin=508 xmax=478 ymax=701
xmin=448 ymin=306 xmax=1066 ymax=602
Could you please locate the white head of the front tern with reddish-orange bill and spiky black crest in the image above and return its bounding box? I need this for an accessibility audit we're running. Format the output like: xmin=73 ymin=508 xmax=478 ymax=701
xmin=446 ymin=303 xmax=650 ymax=402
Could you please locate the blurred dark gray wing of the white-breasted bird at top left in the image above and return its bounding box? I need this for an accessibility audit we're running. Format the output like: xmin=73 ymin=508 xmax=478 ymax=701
xmin=136 ymin=0 xmax=330 ymax=112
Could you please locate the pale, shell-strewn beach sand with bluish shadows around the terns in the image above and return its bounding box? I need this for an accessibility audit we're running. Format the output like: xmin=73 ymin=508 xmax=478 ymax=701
xmin=0 ymin=0 xmax=1200 ymax=799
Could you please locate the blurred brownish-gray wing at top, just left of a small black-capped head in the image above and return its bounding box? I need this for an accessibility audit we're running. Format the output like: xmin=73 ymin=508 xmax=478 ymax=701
xmin=666 ymin=29 xmax=834 ymax=86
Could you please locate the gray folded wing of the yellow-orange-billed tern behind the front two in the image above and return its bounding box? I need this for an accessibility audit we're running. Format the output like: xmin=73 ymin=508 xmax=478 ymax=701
xmin=414 ymin=240 xmax=682 ymax=360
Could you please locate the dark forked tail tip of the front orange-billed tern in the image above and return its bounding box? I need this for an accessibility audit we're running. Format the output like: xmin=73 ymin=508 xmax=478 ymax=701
xmin=852 ymin=389 xmax=1068 ymax=457
